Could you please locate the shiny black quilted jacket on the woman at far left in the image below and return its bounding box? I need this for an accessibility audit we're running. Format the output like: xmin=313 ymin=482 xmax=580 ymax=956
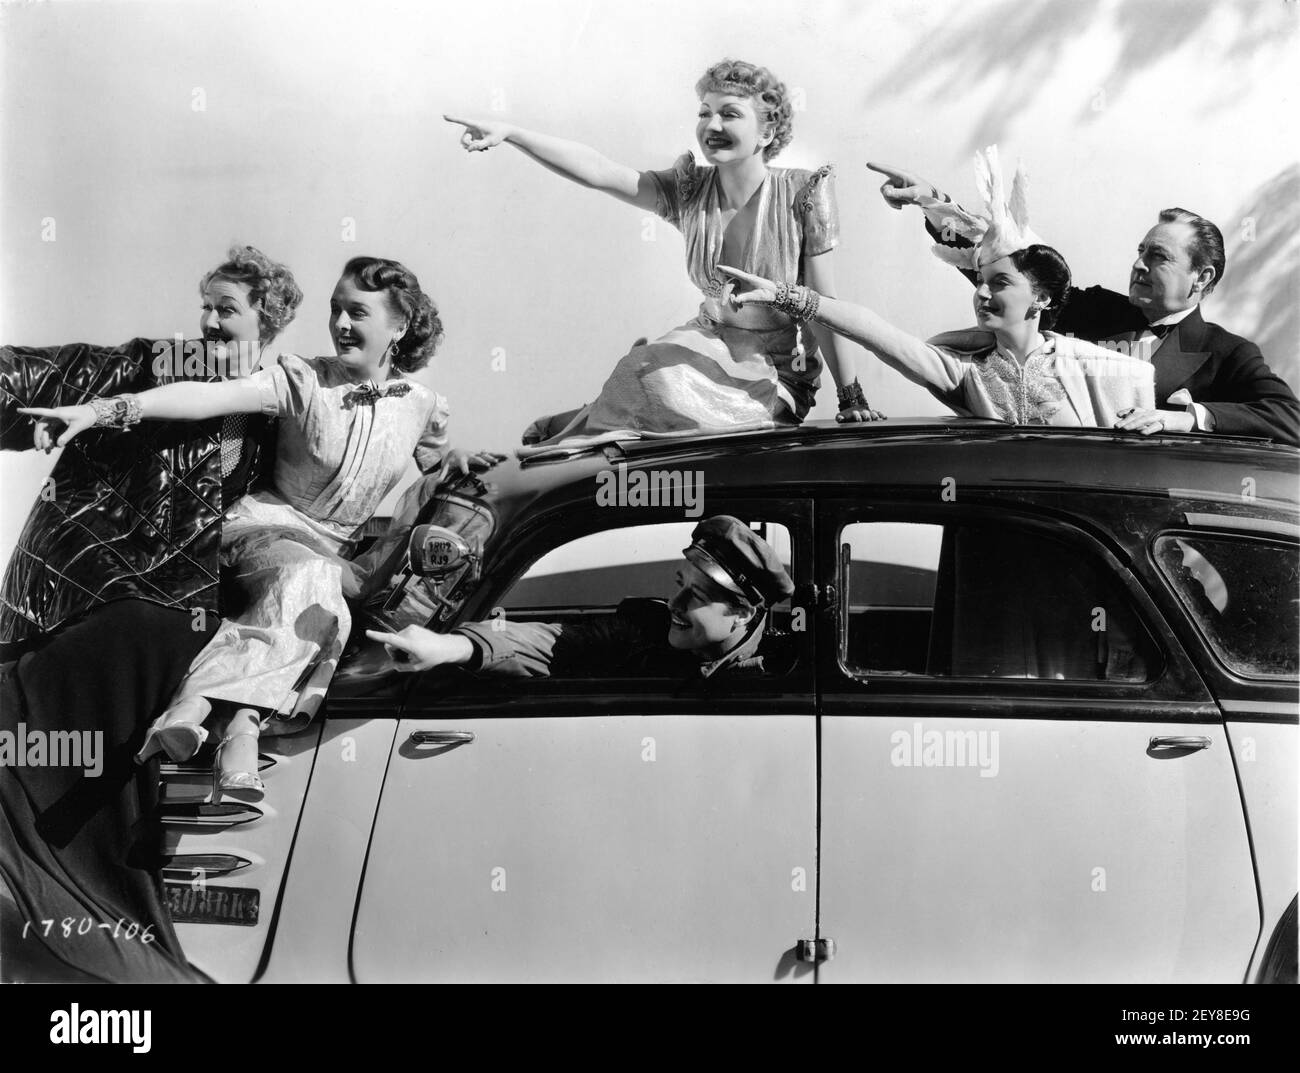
xmin=0 ymin=338 xmax=274 ymax=645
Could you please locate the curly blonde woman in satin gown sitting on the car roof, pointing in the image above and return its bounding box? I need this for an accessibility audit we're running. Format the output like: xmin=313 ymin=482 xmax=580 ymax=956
xmin=447 ymin=60 xmax=879 ymax=455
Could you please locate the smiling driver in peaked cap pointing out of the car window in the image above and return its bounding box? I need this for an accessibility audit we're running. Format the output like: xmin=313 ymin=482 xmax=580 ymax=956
xmin=365 ymin=515 xmax=794 ymax=679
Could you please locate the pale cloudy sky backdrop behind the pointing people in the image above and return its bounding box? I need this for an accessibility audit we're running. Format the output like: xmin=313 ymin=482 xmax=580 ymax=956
xmin=0 ymin=0 xmax=1300 ymax=561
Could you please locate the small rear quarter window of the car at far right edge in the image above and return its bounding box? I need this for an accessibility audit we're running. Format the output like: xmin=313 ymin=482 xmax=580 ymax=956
xmin=1156 ymin=535 xmax=1300 ymax=678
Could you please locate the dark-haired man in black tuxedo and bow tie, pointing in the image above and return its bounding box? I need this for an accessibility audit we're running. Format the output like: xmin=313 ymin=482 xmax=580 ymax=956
xmin=867 ymin=164 xmax=1300 ymax=446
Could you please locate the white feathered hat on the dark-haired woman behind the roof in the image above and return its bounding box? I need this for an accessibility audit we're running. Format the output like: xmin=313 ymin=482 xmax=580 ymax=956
xmin=918 ymin=146 xmax=1045 ymax=269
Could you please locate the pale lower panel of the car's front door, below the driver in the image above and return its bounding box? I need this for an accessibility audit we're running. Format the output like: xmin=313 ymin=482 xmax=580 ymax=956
xmin=352 ymin=714 xmax=816 ymax=982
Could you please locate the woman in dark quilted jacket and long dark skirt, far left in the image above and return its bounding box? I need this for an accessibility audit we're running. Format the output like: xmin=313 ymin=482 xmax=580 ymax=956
xmin=0 ymin=246 xmax=302 ymax=981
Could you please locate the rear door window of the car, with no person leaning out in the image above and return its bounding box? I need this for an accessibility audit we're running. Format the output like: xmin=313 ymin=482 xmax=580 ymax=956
xmin=840 ymin=522 xmax=1160 ymax=682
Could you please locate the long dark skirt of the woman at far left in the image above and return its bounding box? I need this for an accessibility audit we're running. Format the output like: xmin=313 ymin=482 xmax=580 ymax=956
xmin=0 ymin=600 xmax=217 ymax=982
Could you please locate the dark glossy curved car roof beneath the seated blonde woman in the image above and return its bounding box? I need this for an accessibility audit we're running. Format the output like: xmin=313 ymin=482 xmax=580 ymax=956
xmin=473 ymin=417 xmax=1300 ymax=524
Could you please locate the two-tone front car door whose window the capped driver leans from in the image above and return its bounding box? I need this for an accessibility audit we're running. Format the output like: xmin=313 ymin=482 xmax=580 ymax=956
xmin=351 ymin=501 xmax=816 ymax=982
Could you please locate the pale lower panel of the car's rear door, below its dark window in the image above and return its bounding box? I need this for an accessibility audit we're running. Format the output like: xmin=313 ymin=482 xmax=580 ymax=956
xmin=819 ymin=715 xmax=1260 ymax=983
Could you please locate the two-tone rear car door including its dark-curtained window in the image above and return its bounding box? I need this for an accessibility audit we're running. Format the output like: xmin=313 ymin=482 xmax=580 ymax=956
xmin=818 ymin=493 xmax=1260 ymax=982
